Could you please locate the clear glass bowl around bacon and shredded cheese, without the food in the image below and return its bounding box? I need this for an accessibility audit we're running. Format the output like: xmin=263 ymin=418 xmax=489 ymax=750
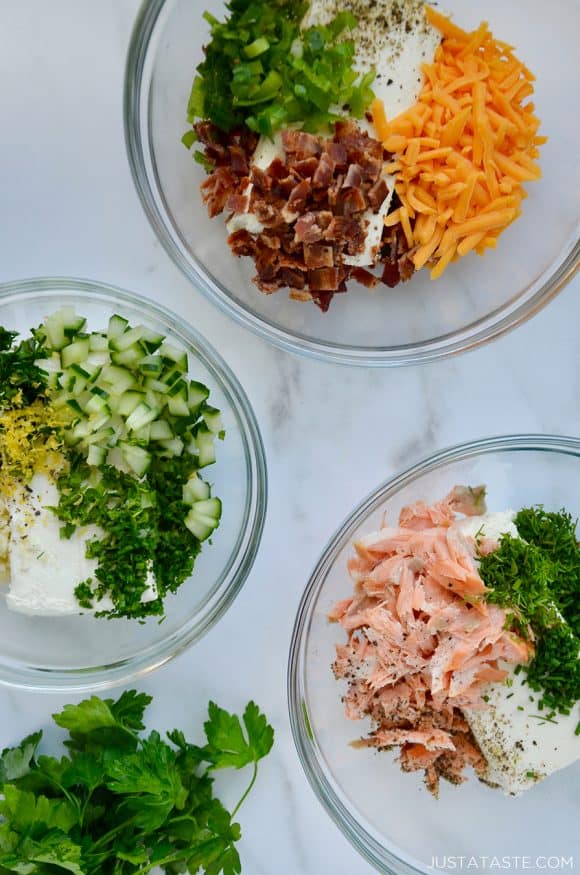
xmin=124 ymin=0 xmax=580 ymax=366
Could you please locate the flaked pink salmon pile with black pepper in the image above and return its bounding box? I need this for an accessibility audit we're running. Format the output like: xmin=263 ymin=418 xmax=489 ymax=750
xmin=329 ymin=486 xmax=532 ymax=794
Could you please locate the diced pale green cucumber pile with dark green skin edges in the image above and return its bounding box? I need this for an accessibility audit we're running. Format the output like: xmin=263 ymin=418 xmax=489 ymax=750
xmin=42 ymin=308 xmax=223 ymax=486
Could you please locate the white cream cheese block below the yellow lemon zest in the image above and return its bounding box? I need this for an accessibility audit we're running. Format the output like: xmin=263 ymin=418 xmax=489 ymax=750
xmin=0 ymin=474 xmax=157 ymax=616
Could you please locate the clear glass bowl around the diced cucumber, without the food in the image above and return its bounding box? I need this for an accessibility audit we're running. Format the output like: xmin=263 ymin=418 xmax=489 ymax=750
xmin=0 ymin=279 xmax=267 ymax=692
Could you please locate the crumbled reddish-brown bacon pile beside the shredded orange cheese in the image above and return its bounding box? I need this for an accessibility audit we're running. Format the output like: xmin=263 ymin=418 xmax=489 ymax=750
xmin=196 ymin=120 xmax=414 ymax=311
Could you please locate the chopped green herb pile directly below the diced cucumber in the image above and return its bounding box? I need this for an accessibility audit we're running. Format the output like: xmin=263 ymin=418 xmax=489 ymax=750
xmin=53 ymin=454 xmax=201 ymax=619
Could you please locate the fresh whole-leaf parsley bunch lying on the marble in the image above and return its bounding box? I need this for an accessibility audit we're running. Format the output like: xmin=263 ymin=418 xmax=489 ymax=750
xmin=0 ymin=690 xmax=274 ymax=875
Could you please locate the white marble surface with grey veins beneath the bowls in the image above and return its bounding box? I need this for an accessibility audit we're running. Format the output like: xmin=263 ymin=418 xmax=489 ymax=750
xmin=0 ymin=0 xmax=580 ymax=875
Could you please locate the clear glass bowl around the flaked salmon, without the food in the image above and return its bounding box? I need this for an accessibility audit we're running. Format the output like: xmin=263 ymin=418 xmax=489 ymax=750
xmin=288 ymin=435 xmax=580 ymax=873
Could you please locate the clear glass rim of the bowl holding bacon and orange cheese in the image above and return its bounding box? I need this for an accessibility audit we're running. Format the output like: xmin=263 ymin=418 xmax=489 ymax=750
xmin=123 ymin=0 xmax=580 ymax=367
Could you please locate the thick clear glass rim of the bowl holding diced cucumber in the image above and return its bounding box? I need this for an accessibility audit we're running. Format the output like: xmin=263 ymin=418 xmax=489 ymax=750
xmin=0 ymin=276 xmax=268 ymax=693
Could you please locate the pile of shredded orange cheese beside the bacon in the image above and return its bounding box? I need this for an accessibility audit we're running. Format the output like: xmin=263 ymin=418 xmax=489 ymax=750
xmin=371 ymin=7 xmax=546 ymax=279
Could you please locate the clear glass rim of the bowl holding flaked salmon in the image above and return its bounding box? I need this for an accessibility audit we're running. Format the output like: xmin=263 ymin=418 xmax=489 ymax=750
xmin=286 ymin=433 xmax=580 ymax=875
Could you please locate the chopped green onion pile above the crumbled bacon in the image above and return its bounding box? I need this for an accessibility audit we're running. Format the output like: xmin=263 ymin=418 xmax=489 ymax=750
xmin=185 ymin=0 xmax=374 ymax=140
